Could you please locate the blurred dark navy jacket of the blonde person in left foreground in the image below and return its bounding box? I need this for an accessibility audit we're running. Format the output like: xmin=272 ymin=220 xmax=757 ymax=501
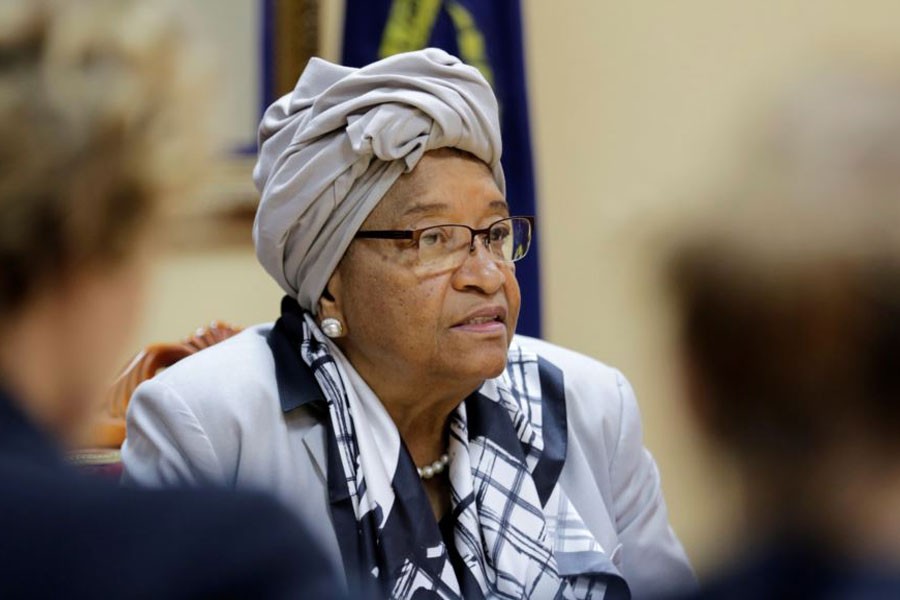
xmin=0 ymin=392 xmax=344 ymax=599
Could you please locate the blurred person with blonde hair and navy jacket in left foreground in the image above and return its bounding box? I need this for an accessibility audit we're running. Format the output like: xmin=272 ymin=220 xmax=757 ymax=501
xmin=0 ymin=0 xmax=340 ymax=598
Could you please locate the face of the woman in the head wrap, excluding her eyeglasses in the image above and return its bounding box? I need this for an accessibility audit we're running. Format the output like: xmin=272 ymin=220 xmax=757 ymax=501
xmin=320 ymin=150 xmax=520 ymax=391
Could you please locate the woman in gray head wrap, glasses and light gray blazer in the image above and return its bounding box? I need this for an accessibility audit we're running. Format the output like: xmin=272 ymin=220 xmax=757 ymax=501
xmin=123 ymin=49 xmax=693 ymax=598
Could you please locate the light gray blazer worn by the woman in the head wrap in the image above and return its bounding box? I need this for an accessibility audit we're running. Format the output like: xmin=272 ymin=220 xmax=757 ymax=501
xmin=122 ymin=324 xmax=694 ymax=598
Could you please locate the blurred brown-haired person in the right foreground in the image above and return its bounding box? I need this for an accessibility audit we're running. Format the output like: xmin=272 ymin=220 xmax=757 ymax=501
xmin=668 ymin=70 xmax=900 ymax=599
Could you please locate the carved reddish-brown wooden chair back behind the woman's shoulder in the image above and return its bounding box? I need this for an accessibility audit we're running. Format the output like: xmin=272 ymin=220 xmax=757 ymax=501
xmin=69 ymin=321 xmax=241 ymax=475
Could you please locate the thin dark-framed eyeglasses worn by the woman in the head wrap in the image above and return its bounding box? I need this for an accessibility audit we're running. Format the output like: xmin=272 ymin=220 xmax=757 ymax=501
xmin=354 ymin=217 xmax=534 ymax=270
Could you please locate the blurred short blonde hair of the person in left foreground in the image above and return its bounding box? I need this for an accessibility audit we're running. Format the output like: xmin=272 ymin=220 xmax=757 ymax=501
xmin=0 ymin=0 xmax=208 ymax=317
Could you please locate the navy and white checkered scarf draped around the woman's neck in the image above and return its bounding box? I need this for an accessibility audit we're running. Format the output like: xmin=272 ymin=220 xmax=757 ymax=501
xmin=301 ymin=314 xmax=606 ymax=600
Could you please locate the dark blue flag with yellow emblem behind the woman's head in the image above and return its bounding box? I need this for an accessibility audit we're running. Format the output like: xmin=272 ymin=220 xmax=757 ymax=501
xmin=343 ymin=0 xmax=541 ymax=337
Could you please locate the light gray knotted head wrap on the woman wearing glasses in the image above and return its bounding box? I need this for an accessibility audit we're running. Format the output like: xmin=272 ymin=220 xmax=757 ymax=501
xmin=253 ymin=48 xmax=505 ymax=312
